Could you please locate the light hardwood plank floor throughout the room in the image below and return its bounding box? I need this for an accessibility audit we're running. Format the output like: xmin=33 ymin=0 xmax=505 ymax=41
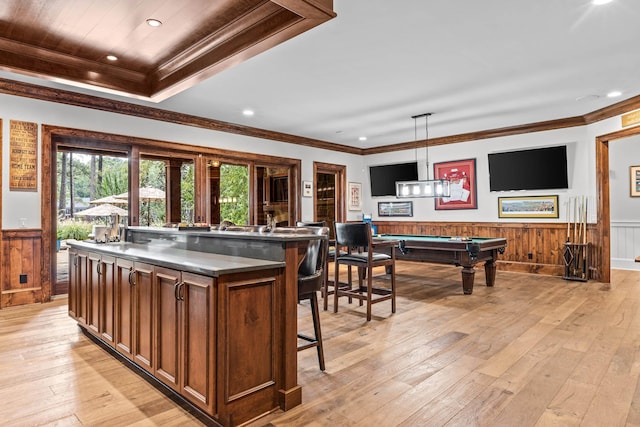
xmin=0 ymin=262 xmax=640 ymax=427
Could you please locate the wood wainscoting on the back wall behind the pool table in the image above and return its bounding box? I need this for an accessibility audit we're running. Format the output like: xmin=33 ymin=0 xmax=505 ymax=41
xmin=375 ymin=221 xmax=602 ymax=280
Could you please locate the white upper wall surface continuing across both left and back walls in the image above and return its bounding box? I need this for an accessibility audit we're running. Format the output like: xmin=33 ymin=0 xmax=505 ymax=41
xmin=0 ymin=88 xmax=640 ymax=229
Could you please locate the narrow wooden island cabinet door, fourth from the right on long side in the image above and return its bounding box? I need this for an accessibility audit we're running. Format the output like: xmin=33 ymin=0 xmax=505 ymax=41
xmin=114 ymin=258 xmax=135 ymax=359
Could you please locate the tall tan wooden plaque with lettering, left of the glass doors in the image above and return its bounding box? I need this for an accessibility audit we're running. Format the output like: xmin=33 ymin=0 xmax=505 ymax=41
xmin=9 ymin=120 xmax=38 ymax=191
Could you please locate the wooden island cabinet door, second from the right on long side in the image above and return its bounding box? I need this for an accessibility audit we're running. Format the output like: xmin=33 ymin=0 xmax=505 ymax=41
xmin=154 ymin=267 xmax=182 ymax=391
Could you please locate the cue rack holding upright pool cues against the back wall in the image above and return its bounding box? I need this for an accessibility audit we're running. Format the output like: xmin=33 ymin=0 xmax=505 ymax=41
xmin=563 ymin=196 xmax=591 ymax=282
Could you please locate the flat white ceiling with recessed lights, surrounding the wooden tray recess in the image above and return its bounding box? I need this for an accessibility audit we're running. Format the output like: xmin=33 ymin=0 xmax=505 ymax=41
xmin=1 ymin=0 xmax=640 ymax=148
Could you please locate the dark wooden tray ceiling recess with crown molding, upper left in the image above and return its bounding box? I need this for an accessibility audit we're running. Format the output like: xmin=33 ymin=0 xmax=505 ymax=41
xmin=0 ymin=0 xmax=336 ymax=102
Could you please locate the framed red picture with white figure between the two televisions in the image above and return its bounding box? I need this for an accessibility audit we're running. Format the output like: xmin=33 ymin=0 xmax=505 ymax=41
xmin=433 ymin=159 xmax=478 ymax=210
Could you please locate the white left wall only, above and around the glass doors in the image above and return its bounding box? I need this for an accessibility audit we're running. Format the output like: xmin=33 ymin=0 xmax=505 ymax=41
xmin=0 ymin=94 xmax=363 ymax=229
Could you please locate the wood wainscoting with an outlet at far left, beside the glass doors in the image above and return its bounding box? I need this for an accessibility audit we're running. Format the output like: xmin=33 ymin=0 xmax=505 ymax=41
xmin=0 ymin=228 xmax=46 ymax=308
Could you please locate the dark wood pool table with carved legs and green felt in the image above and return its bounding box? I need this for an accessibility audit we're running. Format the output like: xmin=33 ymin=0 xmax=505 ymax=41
xmin=374 ymin=234 xmax=507 ymax=295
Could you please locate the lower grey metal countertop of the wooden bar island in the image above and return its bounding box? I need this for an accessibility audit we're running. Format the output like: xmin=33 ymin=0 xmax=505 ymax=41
xmin=67 ymin=240 xmax=285 ymax=277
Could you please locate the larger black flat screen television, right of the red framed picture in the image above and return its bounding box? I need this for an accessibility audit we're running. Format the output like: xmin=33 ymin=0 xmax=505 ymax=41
xmin=489 ymin=145 xmax=569 ymax=191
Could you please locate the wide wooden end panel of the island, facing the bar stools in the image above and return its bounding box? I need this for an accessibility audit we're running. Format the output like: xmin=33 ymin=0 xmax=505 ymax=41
xmin=216 ymin=270 xmax=280 ymax=424
